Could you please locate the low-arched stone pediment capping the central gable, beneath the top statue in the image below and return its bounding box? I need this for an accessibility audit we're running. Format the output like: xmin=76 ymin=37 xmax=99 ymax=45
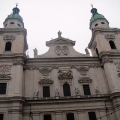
xmin=46 ymin=37 xmax=75 ymax=46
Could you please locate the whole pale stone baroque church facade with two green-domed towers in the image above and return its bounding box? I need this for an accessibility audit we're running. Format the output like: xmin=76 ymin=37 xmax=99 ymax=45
xmin=0 ymin=7 xmax=120 ymax=120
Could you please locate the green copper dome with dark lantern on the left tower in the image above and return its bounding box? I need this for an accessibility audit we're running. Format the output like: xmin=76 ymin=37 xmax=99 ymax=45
xmin=5 ymin=7 xmax=23 ymax=22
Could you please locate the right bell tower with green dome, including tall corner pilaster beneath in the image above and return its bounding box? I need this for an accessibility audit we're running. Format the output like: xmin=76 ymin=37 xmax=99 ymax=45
xmin=88 ymin=8 xmax=120 ymax=93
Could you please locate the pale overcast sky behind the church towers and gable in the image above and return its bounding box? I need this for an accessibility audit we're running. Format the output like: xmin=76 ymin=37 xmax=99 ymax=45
xmin=0 ymin=0 xmax=120 ymax=57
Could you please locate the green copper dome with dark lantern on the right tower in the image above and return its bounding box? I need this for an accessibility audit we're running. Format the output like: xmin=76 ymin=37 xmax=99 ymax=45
xmin=90 ymin=8 xmax=108 ymax=24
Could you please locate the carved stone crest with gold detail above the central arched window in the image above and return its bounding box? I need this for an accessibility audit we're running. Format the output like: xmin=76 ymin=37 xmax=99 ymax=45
xmin=58 ymin=70 xmax=73 ymax=80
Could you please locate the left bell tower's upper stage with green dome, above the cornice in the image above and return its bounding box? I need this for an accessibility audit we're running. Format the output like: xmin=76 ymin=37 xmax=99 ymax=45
xmin=0 ymin=6 xmax=28 ymax=54
